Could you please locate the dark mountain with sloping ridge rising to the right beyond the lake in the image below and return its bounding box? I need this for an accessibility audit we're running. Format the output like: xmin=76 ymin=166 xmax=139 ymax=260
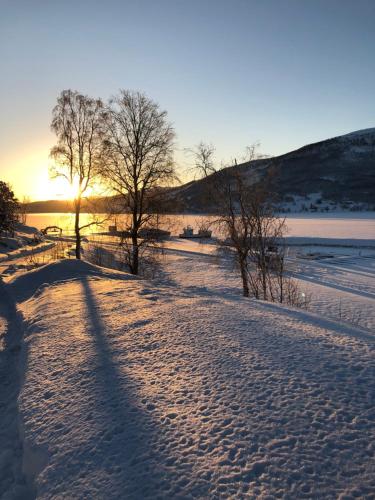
xmin=171 ymin=128 xmax=375 ymax=212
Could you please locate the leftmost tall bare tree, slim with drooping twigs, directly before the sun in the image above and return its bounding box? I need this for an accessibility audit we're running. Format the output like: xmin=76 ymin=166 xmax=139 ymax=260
xmin=50 ymin=90 xmax=103 ymax=259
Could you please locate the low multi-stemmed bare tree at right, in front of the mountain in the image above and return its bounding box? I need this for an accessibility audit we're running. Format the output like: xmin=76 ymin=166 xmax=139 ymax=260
xmin=212 ymin=167 xmax=285 ymax=300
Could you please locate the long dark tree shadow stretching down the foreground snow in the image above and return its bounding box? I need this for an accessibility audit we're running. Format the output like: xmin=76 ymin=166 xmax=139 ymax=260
xmin=81 ymin=278 xmax=184 ymax=498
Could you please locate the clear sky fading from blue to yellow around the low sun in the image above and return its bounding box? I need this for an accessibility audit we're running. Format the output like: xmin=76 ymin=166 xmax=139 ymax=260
xmin=0 ymin=0 xmax=375 ymax=200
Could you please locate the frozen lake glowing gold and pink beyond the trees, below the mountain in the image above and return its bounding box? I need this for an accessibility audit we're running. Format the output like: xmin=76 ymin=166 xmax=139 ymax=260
xmin=27 ymin=212 xmax=375 ymax=239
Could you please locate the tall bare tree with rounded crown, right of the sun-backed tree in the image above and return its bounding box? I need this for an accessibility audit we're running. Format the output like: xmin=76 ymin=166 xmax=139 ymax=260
xmin=102 ymin=90 xmax=176 ymax=274
